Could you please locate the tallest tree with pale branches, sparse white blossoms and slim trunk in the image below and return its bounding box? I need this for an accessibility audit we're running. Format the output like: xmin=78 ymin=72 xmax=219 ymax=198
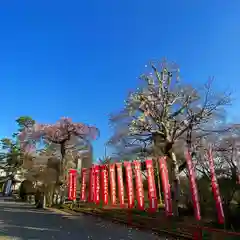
xmin=109 ymin=58 xmax=231 ymax=215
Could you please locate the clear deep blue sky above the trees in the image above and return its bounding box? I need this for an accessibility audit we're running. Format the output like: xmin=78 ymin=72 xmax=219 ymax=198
xmin=0 ymin=0 xmax=240 ymax=157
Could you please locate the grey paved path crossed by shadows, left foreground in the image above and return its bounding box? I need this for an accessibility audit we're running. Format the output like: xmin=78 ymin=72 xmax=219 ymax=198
xmin=0 ymin=198 xmax=166 ymax=240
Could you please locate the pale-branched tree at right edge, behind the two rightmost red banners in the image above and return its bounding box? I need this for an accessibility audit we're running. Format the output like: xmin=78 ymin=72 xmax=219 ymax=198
xmin=191 ymin=131 xmax=240 ymax=227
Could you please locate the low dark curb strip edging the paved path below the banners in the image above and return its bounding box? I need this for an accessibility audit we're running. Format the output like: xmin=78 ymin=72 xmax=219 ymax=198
xmin=55 ymin=209 xmax=192 ymax=239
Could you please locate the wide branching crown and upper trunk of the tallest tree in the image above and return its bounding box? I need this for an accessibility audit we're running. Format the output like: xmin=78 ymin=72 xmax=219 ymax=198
xmin=108 ymin=60 xmax=238 ymax=214
